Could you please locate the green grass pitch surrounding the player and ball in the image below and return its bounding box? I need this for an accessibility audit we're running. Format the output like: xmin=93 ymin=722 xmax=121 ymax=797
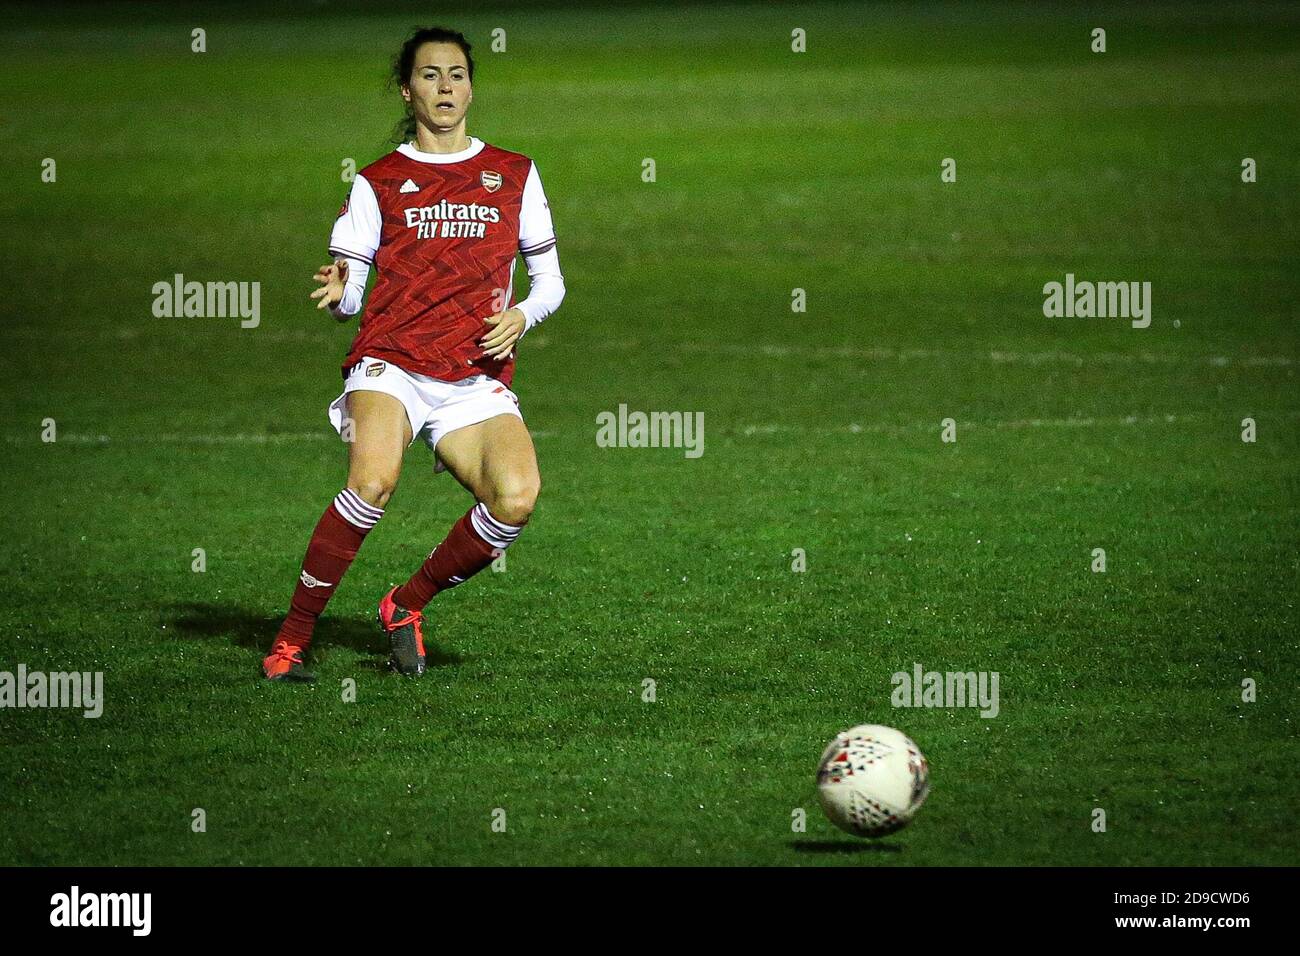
xmin=0 ymin=4 xmax=1300 ymax=865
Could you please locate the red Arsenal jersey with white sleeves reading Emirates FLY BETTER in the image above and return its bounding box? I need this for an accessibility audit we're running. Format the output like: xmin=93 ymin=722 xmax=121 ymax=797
xmin=329 ymin=137 xmax=555 ymax=385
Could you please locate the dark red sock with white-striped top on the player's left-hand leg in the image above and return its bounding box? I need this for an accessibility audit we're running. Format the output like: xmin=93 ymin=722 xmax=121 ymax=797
xmin=276 ymin=488 xmax=384 ymax=648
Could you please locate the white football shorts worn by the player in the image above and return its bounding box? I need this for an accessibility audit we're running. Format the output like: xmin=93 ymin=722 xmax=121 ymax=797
xmin=329 ymin=355 xmax=524 ymax=472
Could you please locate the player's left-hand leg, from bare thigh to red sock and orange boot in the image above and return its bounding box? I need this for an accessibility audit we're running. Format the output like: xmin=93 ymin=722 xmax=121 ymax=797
xmin=263 ymin=390 xmax=411 ymax=680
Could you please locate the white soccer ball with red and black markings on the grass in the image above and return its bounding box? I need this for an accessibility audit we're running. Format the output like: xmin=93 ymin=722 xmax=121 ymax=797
xmin=816 ymin=723 xmax=930 ymax=836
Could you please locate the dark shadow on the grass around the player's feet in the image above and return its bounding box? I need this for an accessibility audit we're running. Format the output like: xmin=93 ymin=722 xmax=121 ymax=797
xmin=164 ymin=601 xmax=463 ymax=671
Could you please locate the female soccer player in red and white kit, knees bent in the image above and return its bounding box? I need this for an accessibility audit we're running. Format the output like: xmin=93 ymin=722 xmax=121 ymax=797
xmin=263 ymin=27 xmax=564 ymax=680
